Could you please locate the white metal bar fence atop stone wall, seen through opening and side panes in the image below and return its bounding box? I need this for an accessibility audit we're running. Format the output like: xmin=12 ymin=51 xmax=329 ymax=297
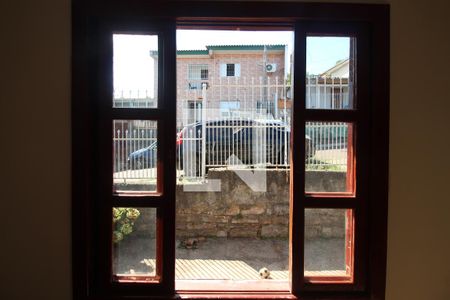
xmin=113 ymin=76 xmax=352 ymax=182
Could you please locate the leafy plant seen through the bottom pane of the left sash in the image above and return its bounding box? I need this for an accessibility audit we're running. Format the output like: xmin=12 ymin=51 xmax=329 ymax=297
xmin=113 ymin=207 xmax=141 ymax=243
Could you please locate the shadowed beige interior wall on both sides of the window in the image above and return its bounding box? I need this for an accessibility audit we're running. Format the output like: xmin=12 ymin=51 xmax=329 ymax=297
xmin=0 ymin=0 xmax=450 ymax=300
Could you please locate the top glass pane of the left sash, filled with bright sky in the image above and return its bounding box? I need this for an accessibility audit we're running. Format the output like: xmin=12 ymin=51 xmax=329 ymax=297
xmin=113 ymin=34 xmax=158 ymax=108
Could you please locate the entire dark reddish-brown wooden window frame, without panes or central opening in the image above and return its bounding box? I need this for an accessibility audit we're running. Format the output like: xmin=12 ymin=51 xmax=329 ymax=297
xmin=72 ymin=0 xmax=389 ymax=299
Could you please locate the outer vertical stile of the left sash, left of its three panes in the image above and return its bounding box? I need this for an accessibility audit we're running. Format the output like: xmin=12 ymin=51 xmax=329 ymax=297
xmin=92 ymin=25 xmax=113 ymax=290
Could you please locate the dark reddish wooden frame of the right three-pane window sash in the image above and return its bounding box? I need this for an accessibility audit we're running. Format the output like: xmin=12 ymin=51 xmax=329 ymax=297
xmin=291 ymin=22 xmax=370 ymax=292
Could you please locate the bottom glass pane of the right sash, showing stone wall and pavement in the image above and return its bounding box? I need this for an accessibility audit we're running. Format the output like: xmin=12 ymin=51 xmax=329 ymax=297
xmin=305 ymin=209 xmax=353 ymax=276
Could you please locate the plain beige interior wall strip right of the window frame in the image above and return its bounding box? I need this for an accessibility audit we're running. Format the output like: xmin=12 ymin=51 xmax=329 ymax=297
xmin=386 ymin=0 xmax=450 ymax=300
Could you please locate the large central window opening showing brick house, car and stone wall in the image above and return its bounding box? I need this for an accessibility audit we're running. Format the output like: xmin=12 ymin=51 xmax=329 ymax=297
xmin=174 ymin=30 xmax=293 ymax=290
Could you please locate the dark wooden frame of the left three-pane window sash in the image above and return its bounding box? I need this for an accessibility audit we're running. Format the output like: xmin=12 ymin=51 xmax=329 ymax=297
xmin=89 ymin=22 xmax=176 ymax=294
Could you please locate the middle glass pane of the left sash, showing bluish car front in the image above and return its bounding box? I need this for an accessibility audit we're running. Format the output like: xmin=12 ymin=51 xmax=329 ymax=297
xmin=113 ymin=120 xmax=158 ymax=193
